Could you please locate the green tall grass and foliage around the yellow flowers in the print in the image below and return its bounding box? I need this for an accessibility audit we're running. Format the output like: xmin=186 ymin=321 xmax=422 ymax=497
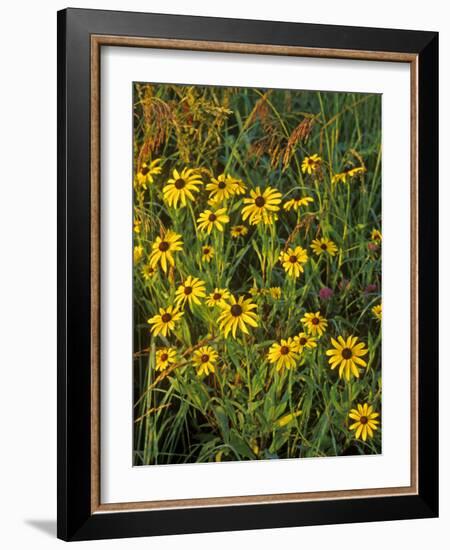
xmin=133 ymin=83 xmax=381 ymax=465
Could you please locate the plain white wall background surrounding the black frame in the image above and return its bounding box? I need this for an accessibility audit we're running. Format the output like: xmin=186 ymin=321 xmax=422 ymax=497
xmin=0 ymin=0 xmax=450 ymax=550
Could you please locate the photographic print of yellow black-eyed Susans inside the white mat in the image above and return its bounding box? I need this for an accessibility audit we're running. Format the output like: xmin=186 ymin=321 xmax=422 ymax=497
xmin=129 ymin=82 xmax=382 ymax=466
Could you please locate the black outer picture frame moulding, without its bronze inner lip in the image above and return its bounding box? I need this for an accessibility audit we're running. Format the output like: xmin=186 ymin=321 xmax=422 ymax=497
xmin=57 ymin=9 xmax=438 ymax=541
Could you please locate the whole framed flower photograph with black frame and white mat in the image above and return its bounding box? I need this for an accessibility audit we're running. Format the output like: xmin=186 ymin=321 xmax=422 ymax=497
xmin=58 ymin=9 xmax=438 ymax=540
